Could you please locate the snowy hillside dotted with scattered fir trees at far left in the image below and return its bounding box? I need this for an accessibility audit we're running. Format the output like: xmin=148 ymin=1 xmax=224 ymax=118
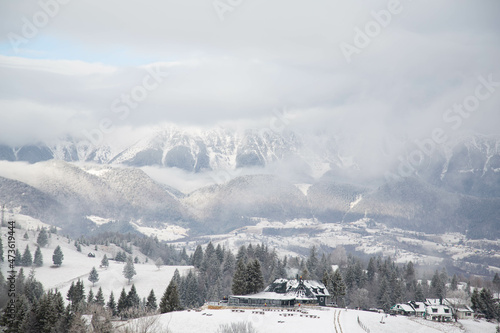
xmin=1 ymin=228 xmax=192 ymax=301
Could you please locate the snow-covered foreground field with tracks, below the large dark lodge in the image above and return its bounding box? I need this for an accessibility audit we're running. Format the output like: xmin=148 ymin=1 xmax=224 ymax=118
xmin=117 ymin=307 xmax=496 ymax=333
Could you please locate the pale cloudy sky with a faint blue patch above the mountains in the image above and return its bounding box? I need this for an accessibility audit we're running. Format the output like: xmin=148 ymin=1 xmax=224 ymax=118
xmin=0 ymin=0 xmax=500 ymax=145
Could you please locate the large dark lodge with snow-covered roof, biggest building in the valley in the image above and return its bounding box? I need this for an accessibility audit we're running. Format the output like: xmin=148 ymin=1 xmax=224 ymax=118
xmin=228 ymin=279 xmax=330 ymax=306
